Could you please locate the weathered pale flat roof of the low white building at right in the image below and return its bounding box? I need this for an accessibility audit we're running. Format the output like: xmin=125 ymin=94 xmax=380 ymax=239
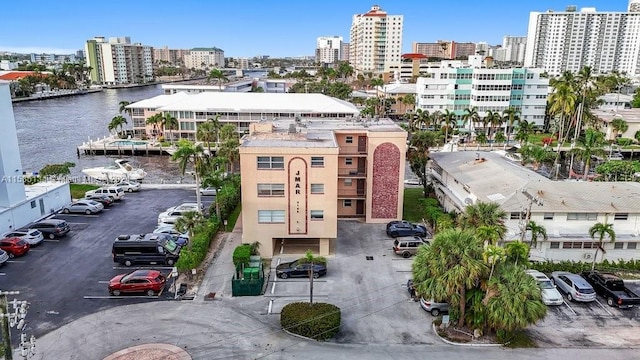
xmin=430 ymin=151 xmax=640 ymax=213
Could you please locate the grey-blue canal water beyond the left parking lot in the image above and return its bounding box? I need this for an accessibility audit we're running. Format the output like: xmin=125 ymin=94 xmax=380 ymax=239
xmin=13 ymin=85 xmax=193 ymax=183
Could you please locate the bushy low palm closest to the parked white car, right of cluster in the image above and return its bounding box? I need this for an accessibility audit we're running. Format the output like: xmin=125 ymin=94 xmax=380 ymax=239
xmin=485 ymin=265 xmax=547 ymax=333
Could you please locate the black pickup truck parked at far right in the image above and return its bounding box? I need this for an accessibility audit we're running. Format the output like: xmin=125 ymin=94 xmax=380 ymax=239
xmin=582 ymin=270 xmax=640 ymax=308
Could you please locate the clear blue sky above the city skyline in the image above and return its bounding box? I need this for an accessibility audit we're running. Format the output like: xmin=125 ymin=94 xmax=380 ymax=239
xmin=0 ymin=0 xmax=628 ymax=57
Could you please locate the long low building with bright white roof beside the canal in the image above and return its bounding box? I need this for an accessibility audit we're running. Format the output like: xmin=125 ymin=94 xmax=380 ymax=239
xmin=127 ymin=91 xmax=359 ymax=140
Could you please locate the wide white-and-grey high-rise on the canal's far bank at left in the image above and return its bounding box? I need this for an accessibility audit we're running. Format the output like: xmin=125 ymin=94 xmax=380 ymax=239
xmin=85 ymin=36 xmax=153 ymax=85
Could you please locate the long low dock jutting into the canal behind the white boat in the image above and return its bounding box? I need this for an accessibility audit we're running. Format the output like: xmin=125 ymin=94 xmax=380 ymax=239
xmin=77 ymin=136 xmax=175 ymax=157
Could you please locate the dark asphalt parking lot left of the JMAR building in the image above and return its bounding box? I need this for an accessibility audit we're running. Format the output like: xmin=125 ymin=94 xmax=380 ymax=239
xmin=0 ymin=188 xmax=213 ymax=336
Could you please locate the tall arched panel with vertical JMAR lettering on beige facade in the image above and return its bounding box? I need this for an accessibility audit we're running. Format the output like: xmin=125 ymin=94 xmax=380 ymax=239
xmin=288 ymin=158 xmax=307 ymax=234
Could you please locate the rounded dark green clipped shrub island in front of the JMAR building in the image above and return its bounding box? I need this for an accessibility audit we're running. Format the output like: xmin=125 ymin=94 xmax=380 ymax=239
xmin=280 ymin=302 xmax=341 ymax=341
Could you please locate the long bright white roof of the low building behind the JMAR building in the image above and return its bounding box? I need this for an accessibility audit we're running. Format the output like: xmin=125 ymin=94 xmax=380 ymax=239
xmin=127 ymin=92 xmax=360 ymax=116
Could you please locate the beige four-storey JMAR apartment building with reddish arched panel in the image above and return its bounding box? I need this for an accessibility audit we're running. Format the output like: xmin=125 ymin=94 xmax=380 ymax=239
xmin=239 ymin=117 xmax=407 ymax=258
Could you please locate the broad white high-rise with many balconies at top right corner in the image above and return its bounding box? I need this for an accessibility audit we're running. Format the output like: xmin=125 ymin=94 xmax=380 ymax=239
xmin=524 ymin=4 xmax=640 ymax=76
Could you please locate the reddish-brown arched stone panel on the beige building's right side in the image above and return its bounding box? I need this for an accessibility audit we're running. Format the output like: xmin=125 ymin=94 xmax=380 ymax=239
xmin=371 ymin=143 xmax=401 ymax=219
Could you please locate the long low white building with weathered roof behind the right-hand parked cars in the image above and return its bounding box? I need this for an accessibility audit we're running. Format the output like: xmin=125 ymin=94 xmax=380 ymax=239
xmin=430 ymin=151 xmax=640 ymax=261
